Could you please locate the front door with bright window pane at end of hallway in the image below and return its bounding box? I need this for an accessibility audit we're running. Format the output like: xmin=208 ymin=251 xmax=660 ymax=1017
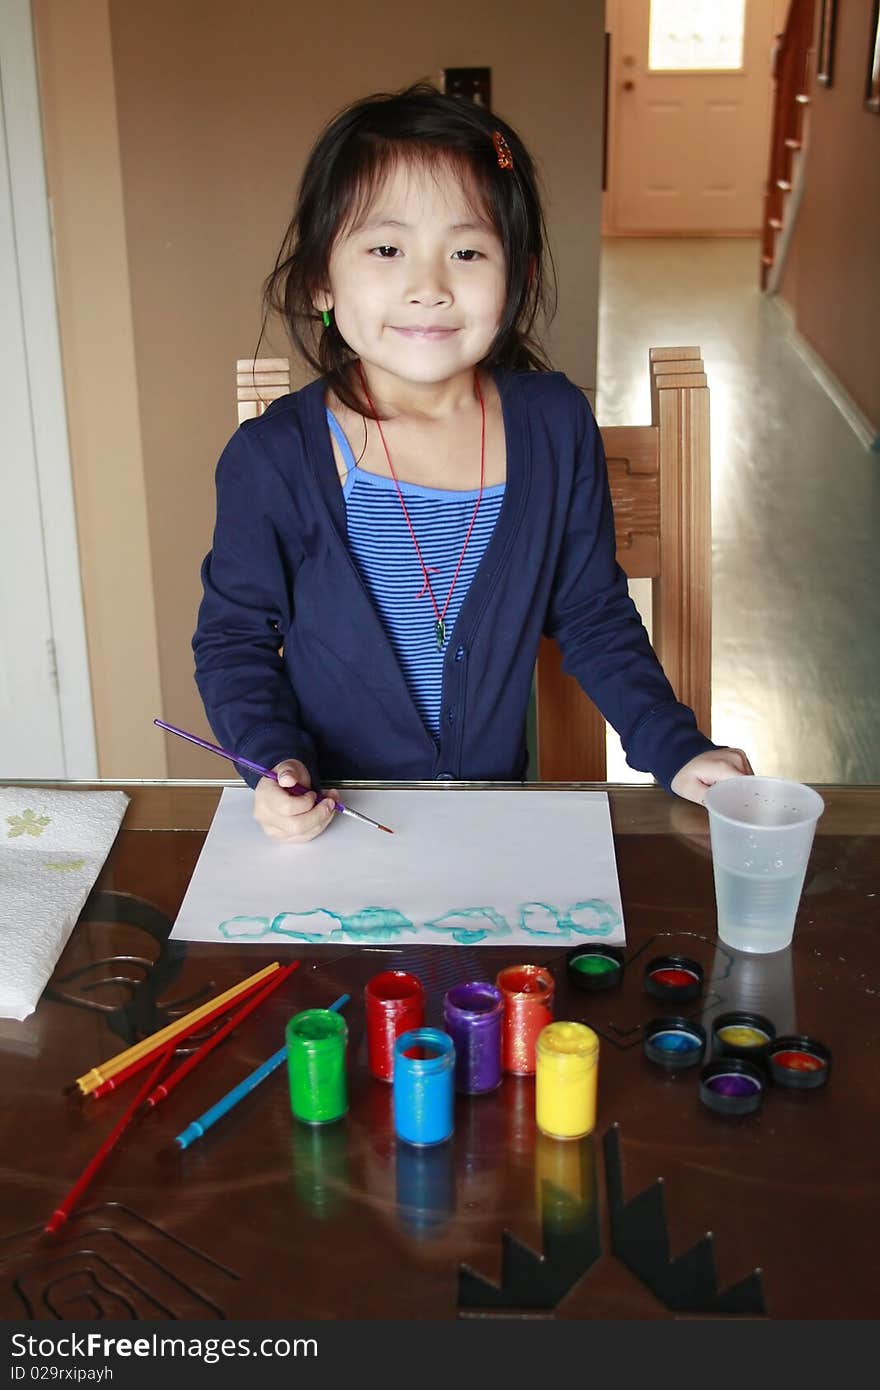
xmin=609 ymin=0 xmax=780 ymax=236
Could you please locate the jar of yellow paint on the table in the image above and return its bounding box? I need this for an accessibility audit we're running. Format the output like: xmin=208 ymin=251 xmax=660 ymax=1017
xmin=535 ymin=1022 xmax=599 ymax=1138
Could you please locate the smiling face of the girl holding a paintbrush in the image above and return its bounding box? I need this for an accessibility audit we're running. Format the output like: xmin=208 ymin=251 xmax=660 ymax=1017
xmin=317 ymin=163 xmax=506 ymax=392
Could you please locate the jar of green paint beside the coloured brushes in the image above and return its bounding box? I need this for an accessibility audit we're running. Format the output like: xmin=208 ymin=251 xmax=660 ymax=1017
xmin=285 ymin=1009 xmax=349 ymax=1125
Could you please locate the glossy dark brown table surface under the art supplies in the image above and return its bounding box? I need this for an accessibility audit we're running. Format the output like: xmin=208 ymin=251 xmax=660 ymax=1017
xmin=0 ymin=784 xmax=880 ymax=1319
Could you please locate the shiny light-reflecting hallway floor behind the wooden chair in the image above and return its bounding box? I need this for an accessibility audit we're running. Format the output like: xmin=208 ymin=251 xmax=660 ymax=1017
xmin=596 ymin=238 xmax=880 ymax=783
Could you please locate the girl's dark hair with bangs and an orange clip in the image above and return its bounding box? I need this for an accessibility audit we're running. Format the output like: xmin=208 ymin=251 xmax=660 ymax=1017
xmin=263 ymin=82 xmax=556 ymax=414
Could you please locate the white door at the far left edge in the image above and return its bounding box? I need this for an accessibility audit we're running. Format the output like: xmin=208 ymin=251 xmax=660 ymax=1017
xmin=0 ymin=0 xmax=96 ymax=778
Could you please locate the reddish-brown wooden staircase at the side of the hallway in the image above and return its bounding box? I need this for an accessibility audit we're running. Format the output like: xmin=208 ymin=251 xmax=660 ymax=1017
xmin=760 ymin=0 xmax=815 ymax=293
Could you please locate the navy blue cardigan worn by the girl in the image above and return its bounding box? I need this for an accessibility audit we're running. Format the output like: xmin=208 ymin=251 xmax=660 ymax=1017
xmin=193 ymin=373 xmax=715 ymax=787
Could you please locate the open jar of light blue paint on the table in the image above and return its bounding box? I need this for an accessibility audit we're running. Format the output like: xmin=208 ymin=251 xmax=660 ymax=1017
xmin=392 ymin=1029 xmax=455 ymax=1144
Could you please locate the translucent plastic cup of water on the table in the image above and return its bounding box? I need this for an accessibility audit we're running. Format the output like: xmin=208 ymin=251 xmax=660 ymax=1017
xmin=705 ymin=777 xmax=824 ymax=954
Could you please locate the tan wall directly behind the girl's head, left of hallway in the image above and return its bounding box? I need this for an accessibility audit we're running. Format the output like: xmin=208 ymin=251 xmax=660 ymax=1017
xmin=33 ymin=0 xmax=603 ymax=777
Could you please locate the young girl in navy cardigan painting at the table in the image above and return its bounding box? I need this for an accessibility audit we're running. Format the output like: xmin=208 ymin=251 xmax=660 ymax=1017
xmin=193 ymin=85 xmax=751 ymax=841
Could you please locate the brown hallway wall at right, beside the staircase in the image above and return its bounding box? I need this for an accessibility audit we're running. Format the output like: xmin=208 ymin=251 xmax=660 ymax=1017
xmin=781 ymin=0 xmax=880 ymax=434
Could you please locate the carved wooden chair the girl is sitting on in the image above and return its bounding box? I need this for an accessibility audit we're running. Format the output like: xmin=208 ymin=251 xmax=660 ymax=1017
xmin=236 ymin=348 xmax=712 ymax=781
